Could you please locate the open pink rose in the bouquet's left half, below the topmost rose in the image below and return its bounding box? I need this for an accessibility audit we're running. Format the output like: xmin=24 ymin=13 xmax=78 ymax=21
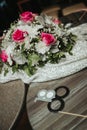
xmin=12 ymin=29 xmax=28 ymax=42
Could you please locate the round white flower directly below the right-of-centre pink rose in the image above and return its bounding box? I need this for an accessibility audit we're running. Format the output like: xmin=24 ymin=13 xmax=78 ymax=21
xmin=35 ymin=41 xmax=51 ymax=54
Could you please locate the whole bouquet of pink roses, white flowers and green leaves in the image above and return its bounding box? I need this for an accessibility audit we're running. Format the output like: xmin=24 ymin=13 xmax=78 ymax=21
xmin=0 ymin=11 xmax=76 ymax=76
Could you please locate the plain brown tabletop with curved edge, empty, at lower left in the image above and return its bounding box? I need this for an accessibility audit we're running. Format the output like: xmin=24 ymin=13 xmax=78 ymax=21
xmin=0 ymin=80 xmax=25 ymax=130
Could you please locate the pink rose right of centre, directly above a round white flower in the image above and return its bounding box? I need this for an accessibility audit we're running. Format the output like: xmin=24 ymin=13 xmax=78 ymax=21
xmin=41 ymin=32 xmax=56 ymax=46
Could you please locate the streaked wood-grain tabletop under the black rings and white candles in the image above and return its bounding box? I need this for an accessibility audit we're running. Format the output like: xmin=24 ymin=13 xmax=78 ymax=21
xmin=27 ymin=69 xmax=87 ymax=130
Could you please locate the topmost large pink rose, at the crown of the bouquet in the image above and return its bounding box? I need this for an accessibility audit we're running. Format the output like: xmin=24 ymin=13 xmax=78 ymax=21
xmin=20 ymin=11 xmax=35 ymax=23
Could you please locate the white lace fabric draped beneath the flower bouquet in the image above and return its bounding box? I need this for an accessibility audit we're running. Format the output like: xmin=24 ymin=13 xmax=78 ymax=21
xmin=0 ymin=23 xmax=87 ymax=83
